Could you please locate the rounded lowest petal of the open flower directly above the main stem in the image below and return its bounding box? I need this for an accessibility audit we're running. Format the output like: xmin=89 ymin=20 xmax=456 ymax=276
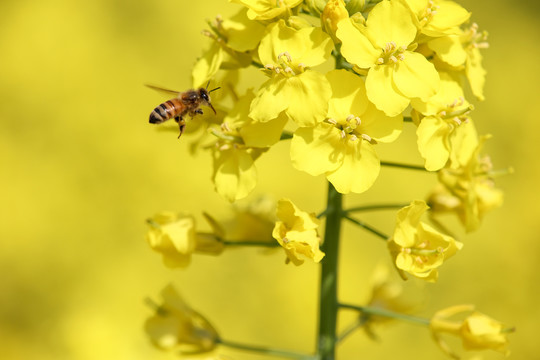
xmin=326 ymin=139 xmax=381 ymax=194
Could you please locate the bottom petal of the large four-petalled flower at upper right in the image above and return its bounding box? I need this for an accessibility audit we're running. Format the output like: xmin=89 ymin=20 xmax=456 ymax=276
xmin=366 ymin=65 xmax=410 ymax=116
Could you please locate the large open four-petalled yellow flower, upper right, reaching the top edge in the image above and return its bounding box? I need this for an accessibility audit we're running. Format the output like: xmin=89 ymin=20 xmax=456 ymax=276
xmin=336 ymin=0 xmax=439 ymax=116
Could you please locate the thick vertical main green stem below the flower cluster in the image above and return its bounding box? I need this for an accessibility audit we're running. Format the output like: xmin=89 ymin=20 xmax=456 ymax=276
xmin=318 ymin=183 xmax=342 ymax=360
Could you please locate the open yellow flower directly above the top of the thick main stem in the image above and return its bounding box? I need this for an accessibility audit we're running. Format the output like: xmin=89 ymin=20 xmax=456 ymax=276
xmin=291 ymin=70 xmax=403 ymax=194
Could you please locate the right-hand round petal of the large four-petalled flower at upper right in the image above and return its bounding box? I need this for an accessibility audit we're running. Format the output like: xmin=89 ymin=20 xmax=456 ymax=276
xmin=393 ymin=51 xmax=440 ymax=101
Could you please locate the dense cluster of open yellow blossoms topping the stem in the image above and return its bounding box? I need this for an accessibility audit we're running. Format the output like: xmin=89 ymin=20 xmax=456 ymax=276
xmin=173 ymin=0 xmax=494 ymax=202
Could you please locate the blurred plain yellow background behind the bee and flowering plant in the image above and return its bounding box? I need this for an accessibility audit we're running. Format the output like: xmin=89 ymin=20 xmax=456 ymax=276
xmin=0 ymin=0 xmax=540 ymax=360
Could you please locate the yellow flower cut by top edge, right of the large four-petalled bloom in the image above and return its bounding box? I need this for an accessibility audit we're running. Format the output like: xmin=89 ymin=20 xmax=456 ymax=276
xmin=405 ymin=0 xmax=471 ymax=37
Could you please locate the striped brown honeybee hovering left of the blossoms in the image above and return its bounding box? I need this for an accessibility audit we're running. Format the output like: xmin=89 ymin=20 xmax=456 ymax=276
xmin=146 ymin=82 xmax=220 ymax=138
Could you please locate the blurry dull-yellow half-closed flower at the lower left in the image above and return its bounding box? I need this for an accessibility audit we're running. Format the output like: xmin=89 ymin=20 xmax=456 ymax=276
xmin=144 ymin=285 xmax=219 ymax=354
